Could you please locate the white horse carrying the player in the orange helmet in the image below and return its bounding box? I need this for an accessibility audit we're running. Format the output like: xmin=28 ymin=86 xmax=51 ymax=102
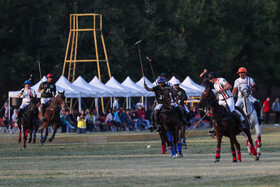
xmin=238 ymin=84 xmax=262 ymax=155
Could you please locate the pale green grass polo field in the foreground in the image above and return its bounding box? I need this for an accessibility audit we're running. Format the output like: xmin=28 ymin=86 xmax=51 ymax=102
xmin=0 ymin=132 xmax=280 ymax=186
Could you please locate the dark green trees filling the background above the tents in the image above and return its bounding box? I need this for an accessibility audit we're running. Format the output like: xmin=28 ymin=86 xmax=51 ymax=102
xmin=0 ymin=0 xmax=280 ymax=103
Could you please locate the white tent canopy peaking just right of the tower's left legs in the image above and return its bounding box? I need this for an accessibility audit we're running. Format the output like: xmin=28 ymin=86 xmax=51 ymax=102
xmin=72 ymin=76 xmax=112 ymax=97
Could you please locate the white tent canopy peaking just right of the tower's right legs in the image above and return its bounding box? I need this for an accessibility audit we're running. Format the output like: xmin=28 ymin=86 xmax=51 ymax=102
xmin=105 ymin=77 xmax=138 ymax=97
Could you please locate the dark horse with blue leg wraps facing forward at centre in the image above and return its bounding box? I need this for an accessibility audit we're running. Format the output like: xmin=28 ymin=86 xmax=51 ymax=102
xmin=160 ymin=88 xmax=183 ymax=158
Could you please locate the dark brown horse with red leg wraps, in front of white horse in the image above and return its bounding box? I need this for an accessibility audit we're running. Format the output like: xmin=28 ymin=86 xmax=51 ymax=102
xmin=198 ymin=87 xmax=259 ymax=162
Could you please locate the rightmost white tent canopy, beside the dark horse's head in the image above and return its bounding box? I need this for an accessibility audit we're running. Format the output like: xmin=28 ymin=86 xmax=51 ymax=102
xmin=180 ymin=76 xmax=204 ymax=96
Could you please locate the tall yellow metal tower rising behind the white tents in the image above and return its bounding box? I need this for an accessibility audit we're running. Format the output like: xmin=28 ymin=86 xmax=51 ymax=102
xmin=62 ymin=13 xmax=111 ymax=112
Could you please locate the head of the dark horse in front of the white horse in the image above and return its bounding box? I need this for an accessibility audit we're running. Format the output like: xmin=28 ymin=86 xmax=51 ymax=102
xmin=197 ymin=86 xmax=216 ymax=110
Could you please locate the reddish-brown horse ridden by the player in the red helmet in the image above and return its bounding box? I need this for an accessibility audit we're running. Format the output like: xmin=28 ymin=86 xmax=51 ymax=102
xmin=39 ymin=91 xmax=65 ymax=145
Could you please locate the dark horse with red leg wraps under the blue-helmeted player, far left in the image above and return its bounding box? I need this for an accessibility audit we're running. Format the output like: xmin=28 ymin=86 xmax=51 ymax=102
xmin=18 ymin=98 xmax=39 ymax=149
